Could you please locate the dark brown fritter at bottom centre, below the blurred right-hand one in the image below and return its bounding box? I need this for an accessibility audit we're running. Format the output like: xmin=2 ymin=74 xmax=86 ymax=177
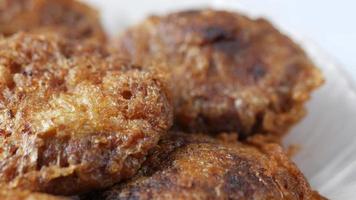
xmin=84 ymin=133 xmax=318 ymax=200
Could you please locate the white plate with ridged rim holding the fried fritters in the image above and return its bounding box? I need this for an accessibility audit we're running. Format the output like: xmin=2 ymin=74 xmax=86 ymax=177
xmin=87 ymin=0 xmax=356 ymax=200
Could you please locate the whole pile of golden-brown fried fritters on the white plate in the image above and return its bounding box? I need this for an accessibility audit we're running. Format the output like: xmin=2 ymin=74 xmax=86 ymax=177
xmin=0 ymin=0 xmax=323 ymax=200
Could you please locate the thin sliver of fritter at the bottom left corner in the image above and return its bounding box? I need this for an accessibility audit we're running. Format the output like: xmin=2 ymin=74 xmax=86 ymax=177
xmin=0 ymin=189 xmax=69 ymax=200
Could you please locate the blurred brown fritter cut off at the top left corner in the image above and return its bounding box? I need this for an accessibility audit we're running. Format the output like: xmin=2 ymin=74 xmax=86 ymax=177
xmin=0 ymin=0 xmax=105 ymax=40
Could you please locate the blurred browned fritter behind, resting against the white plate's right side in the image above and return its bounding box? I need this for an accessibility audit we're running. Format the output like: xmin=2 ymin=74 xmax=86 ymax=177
xmin=118 ymin=10 xmax=322 ymax=137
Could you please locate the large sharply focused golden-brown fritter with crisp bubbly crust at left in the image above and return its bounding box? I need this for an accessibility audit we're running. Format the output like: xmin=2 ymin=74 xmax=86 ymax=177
xmin=0 ymin=33 xmax=172 ymax=195
